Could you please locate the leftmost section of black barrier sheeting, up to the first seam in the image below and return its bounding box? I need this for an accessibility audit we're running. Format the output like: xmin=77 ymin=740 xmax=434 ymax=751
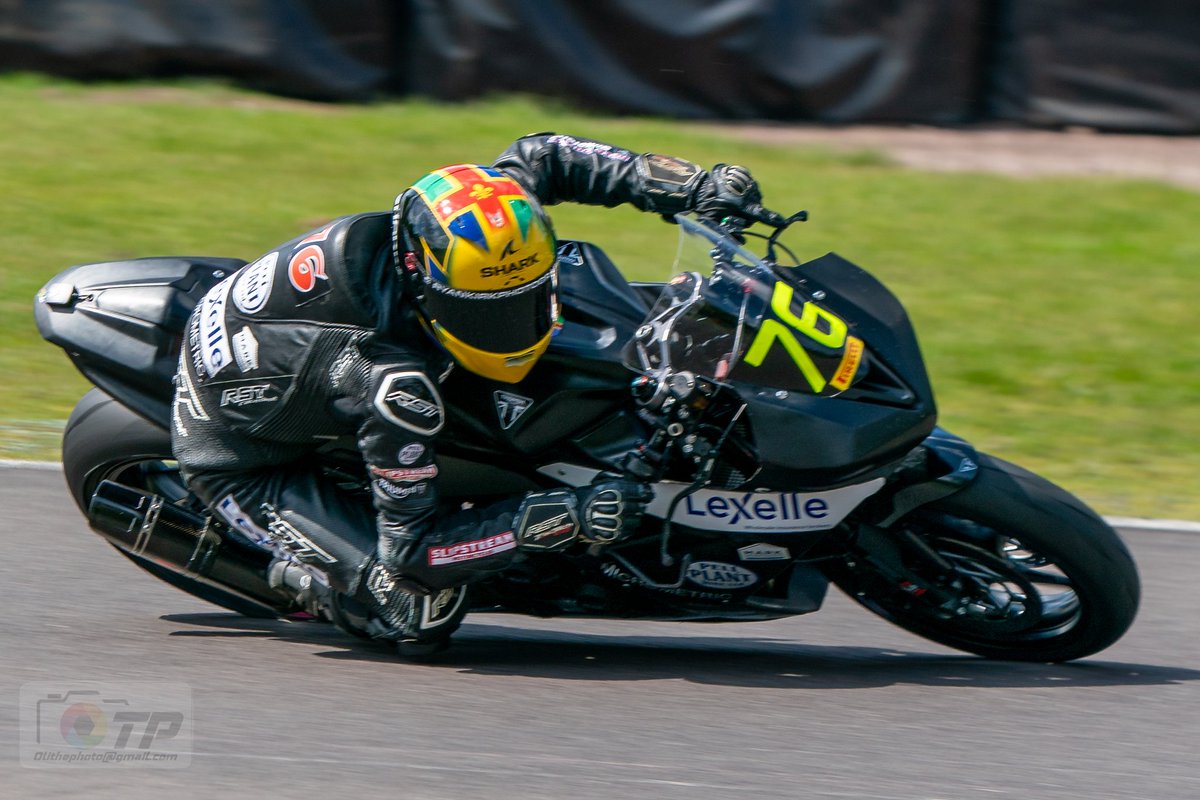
xmin=0 ymin=0 xmax=404 ymax=100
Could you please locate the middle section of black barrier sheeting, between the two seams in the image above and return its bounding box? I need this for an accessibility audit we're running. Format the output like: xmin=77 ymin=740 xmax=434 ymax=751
xmin=403 ymin=0 xmax=982 ymax=122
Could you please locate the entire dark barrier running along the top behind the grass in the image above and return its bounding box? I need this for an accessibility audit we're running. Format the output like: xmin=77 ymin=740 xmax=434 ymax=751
xmin=0 ymin=0 xmax=1200 ymax=133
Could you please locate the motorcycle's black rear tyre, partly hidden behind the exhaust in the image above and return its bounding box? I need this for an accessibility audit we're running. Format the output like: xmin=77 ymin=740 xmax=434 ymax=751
xmin=62 ymin=389 xmax=278 ymax=619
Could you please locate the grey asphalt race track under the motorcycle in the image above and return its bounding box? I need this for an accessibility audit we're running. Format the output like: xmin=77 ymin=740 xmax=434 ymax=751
xmin=0 ymin=469 xmax=1200 ymax=800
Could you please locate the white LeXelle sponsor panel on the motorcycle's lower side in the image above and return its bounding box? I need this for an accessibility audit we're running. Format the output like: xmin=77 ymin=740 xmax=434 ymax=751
xmin=647 ymin=477 xmax=883 ymax=533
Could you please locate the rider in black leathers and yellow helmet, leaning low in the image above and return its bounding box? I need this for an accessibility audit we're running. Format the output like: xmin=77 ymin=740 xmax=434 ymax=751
xmin=172 ymin=133 xmax=779 ymax=646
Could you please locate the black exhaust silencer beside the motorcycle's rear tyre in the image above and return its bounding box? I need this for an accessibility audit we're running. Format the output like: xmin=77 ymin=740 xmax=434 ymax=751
xmin=88 ymin=481 xmax=287 ymax=612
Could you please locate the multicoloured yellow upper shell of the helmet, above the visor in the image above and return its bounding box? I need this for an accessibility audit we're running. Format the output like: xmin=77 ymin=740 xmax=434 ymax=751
xmin=413 ymin=164 xmax=556 ymax=291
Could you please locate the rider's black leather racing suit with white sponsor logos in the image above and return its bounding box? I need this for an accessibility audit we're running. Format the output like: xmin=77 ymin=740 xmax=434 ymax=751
xmin=172 ymin=133 xmax=707 ymax=609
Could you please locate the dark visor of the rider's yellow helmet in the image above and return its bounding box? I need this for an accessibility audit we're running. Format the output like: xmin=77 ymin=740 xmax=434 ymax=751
xmin=425 ymin=270 xmax=557 ymax=353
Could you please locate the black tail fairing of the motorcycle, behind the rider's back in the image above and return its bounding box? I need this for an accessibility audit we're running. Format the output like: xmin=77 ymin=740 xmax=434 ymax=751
xmin=34 ymin=257 xmax=246 ymax=427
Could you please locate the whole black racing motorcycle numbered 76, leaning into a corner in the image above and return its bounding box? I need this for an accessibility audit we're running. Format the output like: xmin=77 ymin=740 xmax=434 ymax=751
xmin=36 ymin=212 xmax=1140 ymax=662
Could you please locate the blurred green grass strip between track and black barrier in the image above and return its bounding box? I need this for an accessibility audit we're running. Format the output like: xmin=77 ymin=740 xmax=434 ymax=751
xmin=0 ymin=76 xmax=1200 ymax=518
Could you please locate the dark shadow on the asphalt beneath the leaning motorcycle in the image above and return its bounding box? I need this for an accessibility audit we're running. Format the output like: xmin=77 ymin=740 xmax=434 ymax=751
xmin=162 ymin=613 xmax=1200 ymax=690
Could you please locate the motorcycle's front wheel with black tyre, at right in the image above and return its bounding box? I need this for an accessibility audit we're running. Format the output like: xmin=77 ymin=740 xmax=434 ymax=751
xmin=828 ymin=453 xmax=1141 ymax=662
